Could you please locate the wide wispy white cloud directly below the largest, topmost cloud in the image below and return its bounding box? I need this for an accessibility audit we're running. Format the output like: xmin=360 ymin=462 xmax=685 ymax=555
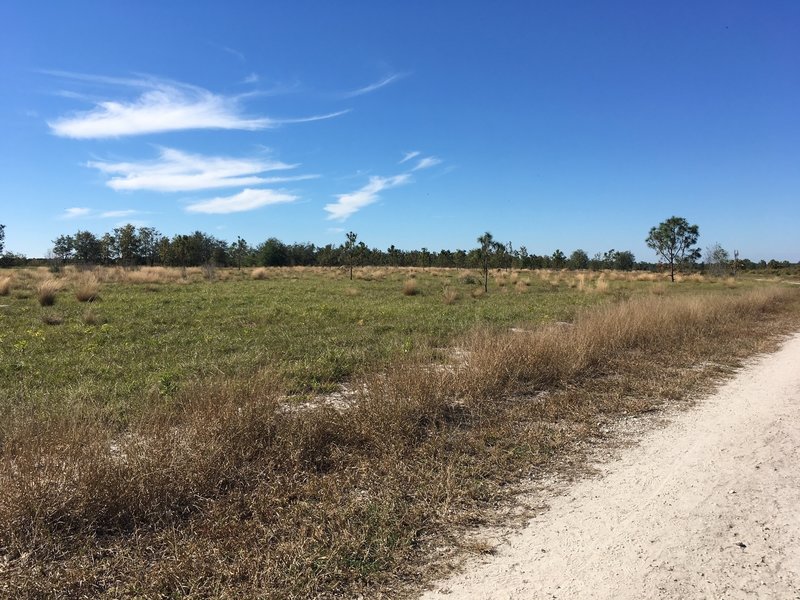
xmin=87 ymin=148 xmax=318 ymax=192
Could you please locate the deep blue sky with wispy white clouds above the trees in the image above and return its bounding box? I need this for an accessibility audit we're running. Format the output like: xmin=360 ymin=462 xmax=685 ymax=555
xmin=0 ymin=0 xmax=800 ymax=261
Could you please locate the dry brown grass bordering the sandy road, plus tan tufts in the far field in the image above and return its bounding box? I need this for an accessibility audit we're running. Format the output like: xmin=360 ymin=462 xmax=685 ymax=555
xmin=0 ymin=269 xmax=800 ymax=598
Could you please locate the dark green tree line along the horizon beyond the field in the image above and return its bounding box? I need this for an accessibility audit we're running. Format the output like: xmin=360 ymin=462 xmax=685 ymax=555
xmin=0 ymin=217 xmax=794 ymax=275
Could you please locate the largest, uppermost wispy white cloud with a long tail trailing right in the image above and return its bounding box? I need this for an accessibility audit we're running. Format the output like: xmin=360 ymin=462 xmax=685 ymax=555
xmin=48 ymin=72 xmax=347 ymax=139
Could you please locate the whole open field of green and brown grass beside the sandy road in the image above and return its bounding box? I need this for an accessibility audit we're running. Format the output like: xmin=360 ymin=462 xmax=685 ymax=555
xmin=0 ymin=268 xmax=800 ymax=598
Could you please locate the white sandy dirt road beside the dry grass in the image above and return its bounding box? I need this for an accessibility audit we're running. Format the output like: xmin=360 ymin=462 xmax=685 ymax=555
xmin=423 ymin=333 xmax=800 ymax=600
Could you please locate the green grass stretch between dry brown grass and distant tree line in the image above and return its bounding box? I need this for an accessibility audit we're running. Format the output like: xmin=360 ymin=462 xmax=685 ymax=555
xmin=0 ymin=270 xmax=602 ymax=415
